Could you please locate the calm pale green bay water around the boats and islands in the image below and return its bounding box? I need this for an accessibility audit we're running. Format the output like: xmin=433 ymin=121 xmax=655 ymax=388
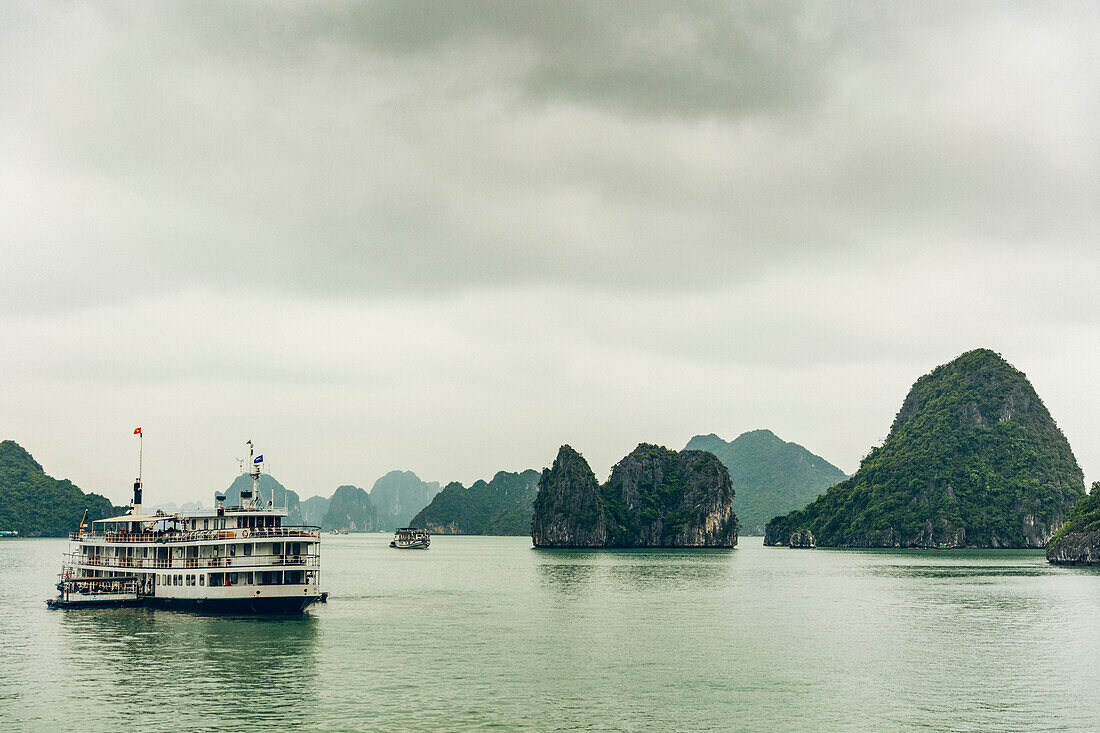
xmin=0 ymin=535 xmax=1100 ymax=731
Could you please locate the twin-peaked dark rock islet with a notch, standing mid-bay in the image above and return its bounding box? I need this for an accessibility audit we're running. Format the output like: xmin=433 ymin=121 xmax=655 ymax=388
xmin=531 ymin=444 xmax=737 ymax=547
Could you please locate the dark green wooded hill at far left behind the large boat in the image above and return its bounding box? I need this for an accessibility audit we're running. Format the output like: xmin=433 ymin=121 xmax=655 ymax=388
xmin=0 ymin=440 xmax=127 ymax=537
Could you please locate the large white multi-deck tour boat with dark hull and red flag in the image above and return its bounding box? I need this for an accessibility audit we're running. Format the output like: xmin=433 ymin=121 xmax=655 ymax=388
xmin=46 ymin=434 xmax=328 ymax=613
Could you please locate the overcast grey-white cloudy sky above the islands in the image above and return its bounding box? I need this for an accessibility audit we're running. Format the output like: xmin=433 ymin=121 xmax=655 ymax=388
xmin=0 ymin=0 xmax=1100 ymax=504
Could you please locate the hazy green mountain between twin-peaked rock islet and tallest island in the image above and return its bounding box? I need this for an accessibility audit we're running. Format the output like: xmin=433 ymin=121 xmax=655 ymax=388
xmin=684 ymin=430 xmax=848 ymax=535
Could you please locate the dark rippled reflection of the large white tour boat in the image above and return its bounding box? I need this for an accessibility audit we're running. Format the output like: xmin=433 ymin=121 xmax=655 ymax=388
xmin=59 ymin=609 xmax=319 ymax=730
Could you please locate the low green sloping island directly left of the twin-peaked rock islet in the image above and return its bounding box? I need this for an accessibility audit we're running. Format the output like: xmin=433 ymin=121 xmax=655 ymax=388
xmin=410 ymin=469 xmax=539 ymax=535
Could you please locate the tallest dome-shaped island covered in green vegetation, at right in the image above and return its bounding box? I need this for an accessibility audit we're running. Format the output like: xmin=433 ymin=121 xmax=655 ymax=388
xmin=765 ymin=349 xmax=1085 ymax=547
